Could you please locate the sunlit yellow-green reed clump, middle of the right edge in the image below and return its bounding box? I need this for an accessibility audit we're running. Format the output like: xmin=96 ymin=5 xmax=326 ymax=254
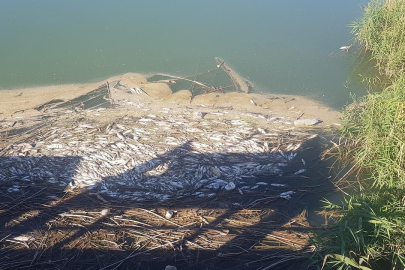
xmin=342 ymin=76 xmax=405 ymax=189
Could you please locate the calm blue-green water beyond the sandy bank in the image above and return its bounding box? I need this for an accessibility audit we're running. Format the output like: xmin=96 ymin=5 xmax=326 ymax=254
xmin=0 ymin=0 xmax=369 ymax=108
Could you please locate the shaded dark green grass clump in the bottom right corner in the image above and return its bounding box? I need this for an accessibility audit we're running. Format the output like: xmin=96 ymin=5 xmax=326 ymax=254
xmin=314 ymin=192 xmax=405 ymax=270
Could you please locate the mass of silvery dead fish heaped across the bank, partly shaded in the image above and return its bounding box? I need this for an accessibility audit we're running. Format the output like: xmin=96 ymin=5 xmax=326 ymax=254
xmin=0 ymin=109 xmax=306 ymax=201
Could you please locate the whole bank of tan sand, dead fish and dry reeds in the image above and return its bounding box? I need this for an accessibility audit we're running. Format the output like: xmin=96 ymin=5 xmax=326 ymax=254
xmin=0 ymin=74 xmax=339 ymax=269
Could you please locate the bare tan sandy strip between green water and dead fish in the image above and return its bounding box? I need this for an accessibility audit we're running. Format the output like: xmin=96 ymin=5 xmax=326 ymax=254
xmin=0 ymin=73 xmax=340 ymax=126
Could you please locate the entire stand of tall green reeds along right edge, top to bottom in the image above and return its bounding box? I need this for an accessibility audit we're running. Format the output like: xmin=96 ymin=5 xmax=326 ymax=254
xmin=314 ymin=0 xmax=405 ymax=270
